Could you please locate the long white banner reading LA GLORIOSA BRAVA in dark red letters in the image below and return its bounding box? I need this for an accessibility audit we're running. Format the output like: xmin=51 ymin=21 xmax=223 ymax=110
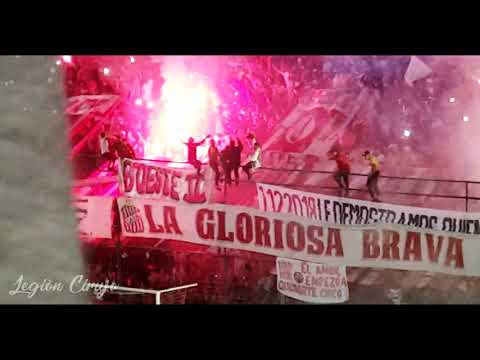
xmin=118 ymin=197 xmax=480 ymax=276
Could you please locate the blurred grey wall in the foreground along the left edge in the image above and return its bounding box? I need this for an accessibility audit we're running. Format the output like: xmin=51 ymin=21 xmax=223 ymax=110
xmin=0 ymin=56 xmax=87 ymax=304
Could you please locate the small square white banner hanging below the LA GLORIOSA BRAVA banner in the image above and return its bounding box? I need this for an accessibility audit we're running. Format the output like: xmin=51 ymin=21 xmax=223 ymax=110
xmin=277 ymin=258 xmax=349 ymax=304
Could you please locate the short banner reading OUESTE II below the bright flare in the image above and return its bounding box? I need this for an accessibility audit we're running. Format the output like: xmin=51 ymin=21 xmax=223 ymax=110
xmin=119 ymin=159 xmax=212 ymax=204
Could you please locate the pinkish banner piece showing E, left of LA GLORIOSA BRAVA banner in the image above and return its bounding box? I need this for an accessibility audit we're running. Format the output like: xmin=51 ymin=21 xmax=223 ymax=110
xmin=73 ymin=196 xmax=113 ymax=238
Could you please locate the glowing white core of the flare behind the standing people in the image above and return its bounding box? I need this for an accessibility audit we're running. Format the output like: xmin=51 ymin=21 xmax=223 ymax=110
xmin=145 ymin=64 xmax=219 ymax=161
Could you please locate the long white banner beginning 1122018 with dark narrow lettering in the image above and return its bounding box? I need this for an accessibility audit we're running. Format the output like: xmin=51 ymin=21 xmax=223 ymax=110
xmin=257 ymin=183 xmax=480 ymax=235
